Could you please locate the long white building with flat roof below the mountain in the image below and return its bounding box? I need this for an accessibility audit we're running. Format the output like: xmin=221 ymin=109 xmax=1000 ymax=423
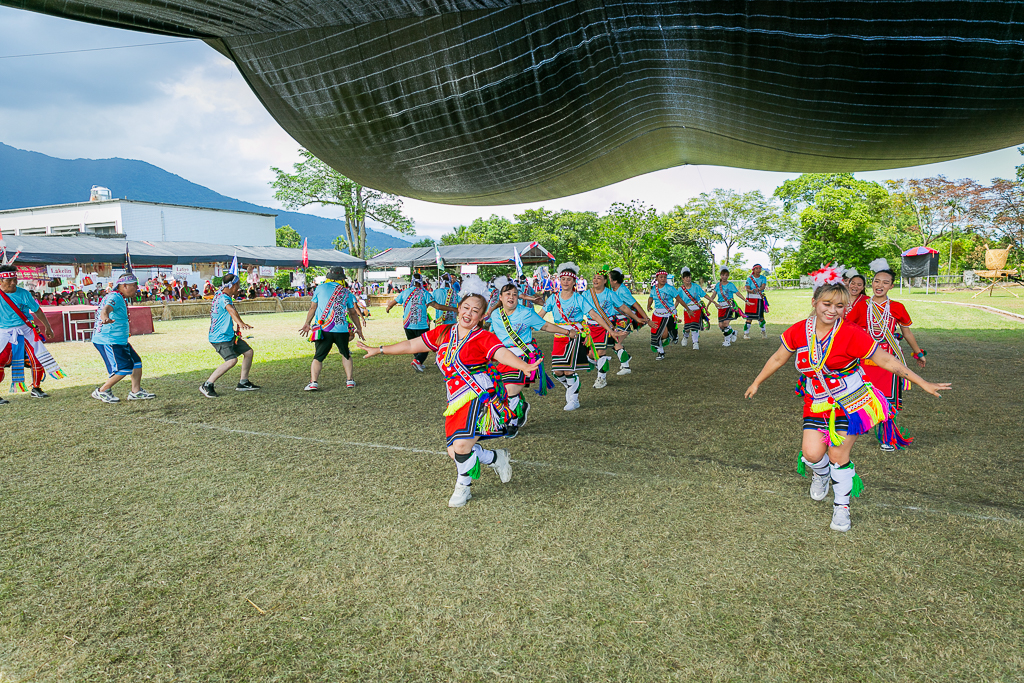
xmin=0 ymin=193 xmax=276 ymax=247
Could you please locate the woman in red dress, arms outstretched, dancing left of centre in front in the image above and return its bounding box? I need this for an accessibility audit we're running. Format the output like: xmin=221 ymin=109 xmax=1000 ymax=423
xmin=356 ymin=292 xmax=541 ymax=508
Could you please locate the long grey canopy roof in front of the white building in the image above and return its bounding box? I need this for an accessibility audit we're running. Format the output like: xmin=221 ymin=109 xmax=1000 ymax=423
xmin=4 ymin=236 xmax=366 ymax=268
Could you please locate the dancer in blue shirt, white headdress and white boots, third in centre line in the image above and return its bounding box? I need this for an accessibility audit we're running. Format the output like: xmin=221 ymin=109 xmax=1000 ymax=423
xmin=543 ymin=261 xmax=626 ymax=411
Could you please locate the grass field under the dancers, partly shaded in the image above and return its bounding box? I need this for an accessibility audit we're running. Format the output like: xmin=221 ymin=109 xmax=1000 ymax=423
xmin=0 ymin=292 xmax=1024 ymax=682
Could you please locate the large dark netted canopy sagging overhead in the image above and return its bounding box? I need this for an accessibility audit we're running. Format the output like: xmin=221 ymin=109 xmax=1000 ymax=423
xmin=8 ymin=0 xmax=1024 ymax=204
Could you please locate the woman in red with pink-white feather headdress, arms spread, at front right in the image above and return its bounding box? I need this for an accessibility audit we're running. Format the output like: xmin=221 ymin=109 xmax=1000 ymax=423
xmin=744 ymin=267 xmax=950 ymax=531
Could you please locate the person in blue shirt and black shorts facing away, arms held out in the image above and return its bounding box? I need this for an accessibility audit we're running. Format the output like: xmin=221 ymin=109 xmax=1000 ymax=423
xmin=299 ymin=265 xmax=366 ymax=391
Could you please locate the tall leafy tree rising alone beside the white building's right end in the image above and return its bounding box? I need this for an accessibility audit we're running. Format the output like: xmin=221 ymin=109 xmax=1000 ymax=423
xmin=270 ymin=150 xmax=416 ymax=258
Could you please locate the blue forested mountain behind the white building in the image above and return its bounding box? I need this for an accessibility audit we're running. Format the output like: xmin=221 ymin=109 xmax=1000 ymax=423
xmin=0 ymin=142 xmax=410 ymax=249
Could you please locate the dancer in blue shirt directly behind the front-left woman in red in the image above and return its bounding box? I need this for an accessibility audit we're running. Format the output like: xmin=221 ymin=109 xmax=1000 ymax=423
xmin=490 ymin=283 xmax=578 ymax=438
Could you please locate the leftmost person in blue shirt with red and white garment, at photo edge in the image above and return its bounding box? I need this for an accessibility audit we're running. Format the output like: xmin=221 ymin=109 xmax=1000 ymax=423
xmin=0 ymin=257 xmax=63 ymax=405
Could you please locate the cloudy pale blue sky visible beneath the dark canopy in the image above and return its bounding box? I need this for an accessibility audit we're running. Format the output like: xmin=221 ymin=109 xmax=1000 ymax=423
xmin=0 ymin=7 xmax=1024 ymax=262
